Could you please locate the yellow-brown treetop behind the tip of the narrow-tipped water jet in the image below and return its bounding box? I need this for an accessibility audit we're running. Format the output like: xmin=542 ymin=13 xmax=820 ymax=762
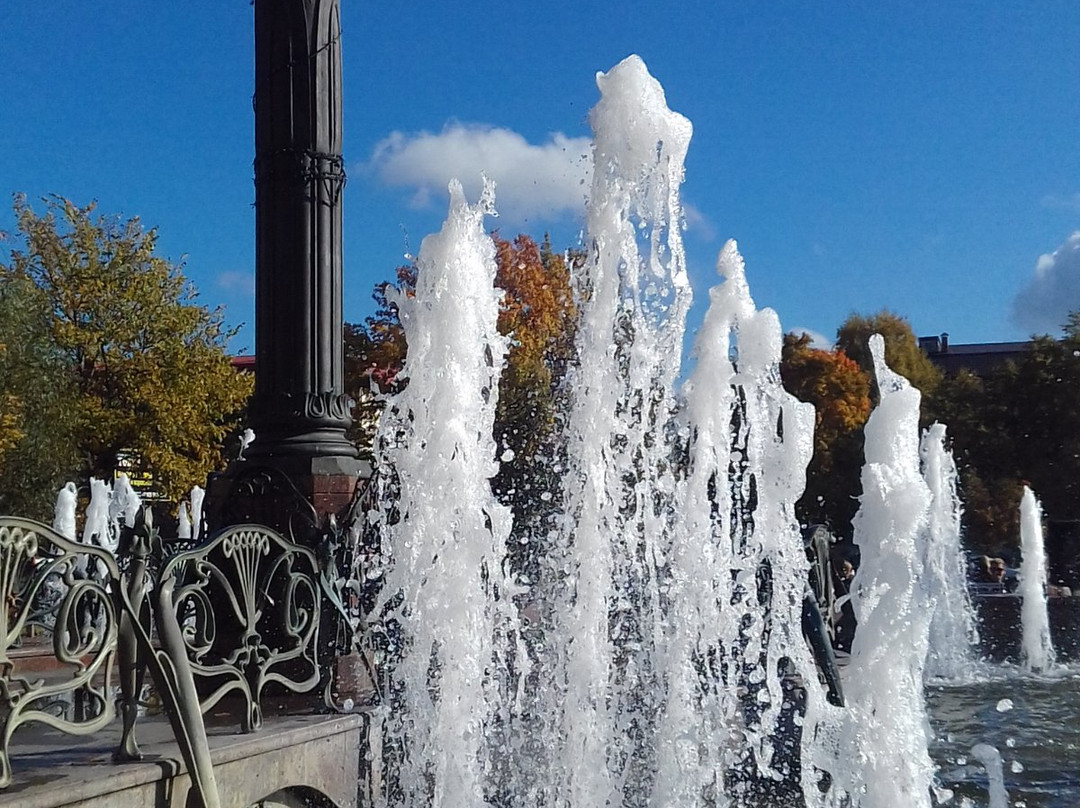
xmin=836 ymin=309 xmax=942 ymax=401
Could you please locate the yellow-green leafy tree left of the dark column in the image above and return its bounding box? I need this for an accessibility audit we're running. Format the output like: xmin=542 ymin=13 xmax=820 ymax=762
xmin=0 ymin=196 xmax=252 ymax=512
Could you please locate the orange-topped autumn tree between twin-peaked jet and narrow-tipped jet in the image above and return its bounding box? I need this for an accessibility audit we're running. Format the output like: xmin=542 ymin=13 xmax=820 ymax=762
xmin=780 ymin=334 xmax=870 ymax=536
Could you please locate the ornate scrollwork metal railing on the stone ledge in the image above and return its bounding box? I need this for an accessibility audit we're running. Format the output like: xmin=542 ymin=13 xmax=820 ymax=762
xmin=0 ymin=505 xmax=375 ymax=808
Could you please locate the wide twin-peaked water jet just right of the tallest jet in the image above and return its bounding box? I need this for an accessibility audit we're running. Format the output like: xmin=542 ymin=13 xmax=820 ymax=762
xmin=652 ymin=241 xmax=824 ymax=806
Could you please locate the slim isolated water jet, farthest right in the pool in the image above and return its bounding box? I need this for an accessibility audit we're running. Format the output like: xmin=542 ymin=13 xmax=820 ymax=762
xmin=1017 ymin=486 xmax=1054 ymax=671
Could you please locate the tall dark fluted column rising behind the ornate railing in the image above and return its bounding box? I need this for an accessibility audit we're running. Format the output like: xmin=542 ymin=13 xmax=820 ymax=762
xmin=212 ymin=0 xmax=367 ymax=526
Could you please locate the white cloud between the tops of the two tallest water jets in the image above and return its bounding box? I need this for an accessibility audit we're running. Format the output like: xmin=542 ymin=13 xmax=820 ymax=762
xmin=367 ymin=123 xmax=592 ymax=223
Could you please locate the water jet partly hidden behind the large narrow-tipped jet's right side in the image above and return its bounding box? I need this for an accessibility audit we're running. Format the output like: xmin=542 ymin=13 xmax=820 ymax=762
xmin=919 ymin=423 xmax=978 ymax=679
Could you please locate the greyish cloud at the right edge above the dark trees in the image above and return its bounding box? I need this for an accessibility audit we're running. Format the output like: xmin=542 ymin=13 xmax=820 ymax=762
xmin=1012 ymin=230 xmax=1080 ymax=336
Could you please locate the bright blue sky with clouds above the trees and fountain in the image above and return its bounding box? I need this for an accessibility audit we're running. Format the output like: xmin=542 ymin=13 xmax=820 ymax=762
xmin=6 ymin=0 xmax=1080 ymax=350
